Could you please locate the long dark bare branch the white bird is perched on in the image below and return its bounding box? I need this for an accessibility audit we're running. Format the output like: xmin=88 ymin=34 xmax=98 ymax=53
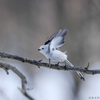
xmin=0 ymin=52 xmax=100 ymax=74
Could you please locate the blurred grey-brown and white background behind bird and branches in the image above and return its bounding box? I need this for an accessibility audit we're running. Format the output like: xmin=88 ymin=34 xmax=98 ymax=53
xmin=0 ymin=0 xmax=100 ymax=100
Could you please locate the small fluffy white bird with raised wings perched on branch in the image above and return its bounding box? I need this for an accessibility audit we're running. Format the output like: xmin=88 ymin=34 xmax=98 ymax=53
xmin=38 ymin=29 xmax=85 ymax=80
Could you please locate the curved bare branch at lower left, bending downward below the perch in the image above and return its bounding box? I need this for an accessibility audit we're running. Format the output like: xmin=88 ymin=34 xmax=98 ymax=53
xmin=0 ymin=62 xmax=34 ymax=100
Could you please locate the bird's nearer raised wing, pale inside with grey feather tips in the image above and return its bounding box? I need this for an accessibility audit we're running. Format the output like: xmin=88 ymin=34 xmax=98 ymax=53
xmin=50 ymin=29 xmax=67 ymax=48
